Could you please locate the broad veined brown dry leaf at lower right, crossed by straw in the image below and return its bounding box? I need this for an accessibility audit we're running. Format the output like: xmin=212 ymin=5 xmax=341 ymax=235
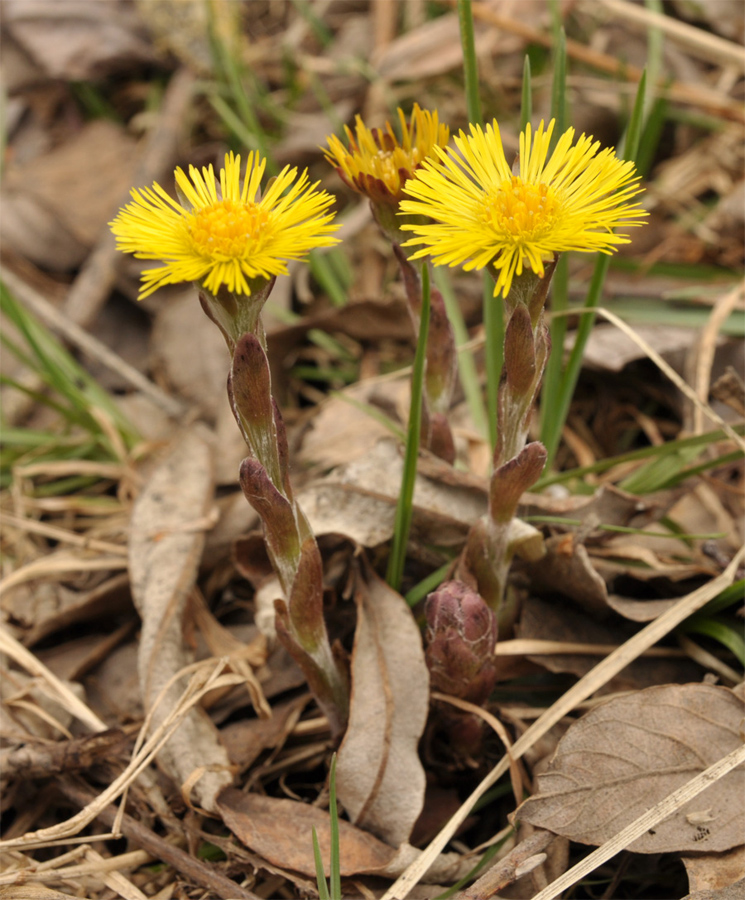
xmin=517 ymin=684 xmax=745 ymax=853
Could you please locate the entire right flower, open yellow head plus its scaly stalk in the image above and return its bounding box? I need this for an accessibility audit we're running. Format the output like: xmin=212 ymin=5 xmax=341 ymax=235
xmin=401 ymin=121 xmax=646 ymax=633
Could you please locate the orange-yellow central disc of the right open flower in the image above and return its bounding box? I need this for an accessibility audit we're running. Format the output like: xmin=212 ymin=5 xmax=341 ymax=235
xmin=486 ymin=175 xmax=560 ymax=240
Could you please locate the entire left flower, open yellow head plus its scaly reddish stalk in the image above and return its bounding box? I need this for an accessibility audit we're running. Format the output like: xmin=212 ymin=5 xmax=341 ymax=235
xmin=111 ymin=153 xmax=349 ymax=734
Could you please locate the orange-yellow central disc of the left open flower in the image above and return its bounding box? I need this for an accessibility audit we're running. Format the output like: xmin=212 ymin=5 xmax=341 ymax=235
xmin=189 ymin=200 xmax=268 ymax=258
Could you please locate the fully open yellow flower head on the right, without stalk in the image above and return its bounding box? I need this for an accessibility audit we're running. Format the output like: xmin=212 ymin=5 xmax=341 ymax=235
xmin=401 ymin=120 xmax=647 ymax=297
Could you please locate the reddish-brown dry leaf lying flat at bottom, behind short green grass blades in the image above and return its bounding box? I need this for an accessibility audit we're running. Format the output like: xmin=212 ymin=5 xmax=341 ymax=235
xmin=217 ymin=788 xmax=474 ymax=882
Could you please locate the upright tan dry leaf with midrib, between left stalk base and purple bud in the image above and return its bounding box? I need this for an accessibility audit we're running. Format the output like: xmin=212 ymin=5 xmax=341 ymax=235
xmin=336 ymin=572 xmax=429 ymax=847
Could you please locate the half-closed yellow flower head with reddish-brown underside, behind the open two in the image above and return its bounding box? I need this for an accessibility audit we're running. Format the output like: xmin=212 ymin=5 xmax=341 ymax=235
xmin=325 ymin=103 xmax=450 ymax=206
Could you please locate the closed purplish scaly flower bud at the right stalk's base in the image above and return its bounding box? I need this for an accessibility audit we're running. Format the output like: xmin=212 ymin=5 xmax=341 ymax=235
xmin=425 ymin=581 xmax=497 ymax=706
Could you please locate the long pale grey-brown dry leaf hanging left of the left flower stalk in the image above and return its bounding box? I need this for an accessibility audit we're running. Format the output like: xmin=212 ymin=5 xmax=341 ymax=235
xmin=129 ymin=431 xmax=232 ymax=809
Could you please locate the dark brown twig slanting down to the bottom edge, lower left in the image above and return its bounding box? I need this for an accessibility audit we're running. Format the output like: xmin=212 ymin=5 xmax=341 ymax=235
xmin=57 ymin=776 xmax=260 ymax=900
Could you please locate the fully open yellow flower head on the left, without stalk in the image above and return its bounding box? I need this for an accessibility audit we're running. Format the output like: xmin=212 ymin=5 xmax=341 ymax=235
xmin=110 ymin=153 xmax=338 ymax=299
